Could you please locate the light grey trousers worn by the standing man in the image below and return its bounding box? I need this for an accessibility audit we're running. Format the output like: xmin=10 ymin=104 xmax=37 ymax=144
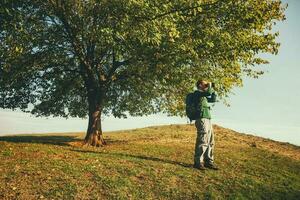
xmin=194 ymin=118 xmax=215 ymax=165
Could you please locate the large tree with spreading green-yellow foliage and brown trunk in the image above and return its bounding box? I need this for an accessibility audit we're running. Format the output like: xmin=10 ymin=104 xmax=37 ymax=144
xmin=0 ymin=0 xmax=285 ymax=146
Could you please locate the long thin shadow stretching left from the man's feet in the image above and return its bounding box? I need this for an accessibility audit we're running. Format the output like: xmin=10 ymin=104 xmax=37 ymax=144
xmin=71 ymin=149 xmax=193 ymax=168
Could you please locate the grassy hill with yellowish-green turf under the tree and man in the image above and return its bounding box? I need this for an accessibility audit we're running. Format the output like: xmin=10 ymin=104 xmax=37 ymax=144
xmin=0 ymin=125 xmax=300 ymax=200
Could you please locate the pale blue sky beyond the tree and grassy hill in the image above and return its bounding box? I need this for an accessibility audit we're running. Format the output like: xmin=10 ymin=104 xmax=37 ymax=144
xmin=0 ymin=0 xmax=300 ymax=145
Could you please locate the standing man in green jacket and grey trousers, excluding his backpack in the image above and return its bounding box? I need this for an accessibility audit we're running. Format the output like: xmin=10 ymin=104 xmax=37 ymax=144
xmin=194 ymin=80 xmax=218 ymax=170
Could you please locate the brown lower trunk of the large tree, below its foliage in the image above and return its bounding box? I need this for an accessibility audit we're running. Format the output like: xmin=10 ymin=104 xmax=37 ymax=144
xmin=84 ymin=106 xmax=106 ymax=147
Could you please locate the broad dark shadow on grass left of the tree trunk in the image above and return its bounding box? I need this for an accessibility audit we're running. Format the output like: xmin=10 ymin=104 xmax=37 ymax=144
xmin=0 ymin=135 xmax=82 ymax=146
